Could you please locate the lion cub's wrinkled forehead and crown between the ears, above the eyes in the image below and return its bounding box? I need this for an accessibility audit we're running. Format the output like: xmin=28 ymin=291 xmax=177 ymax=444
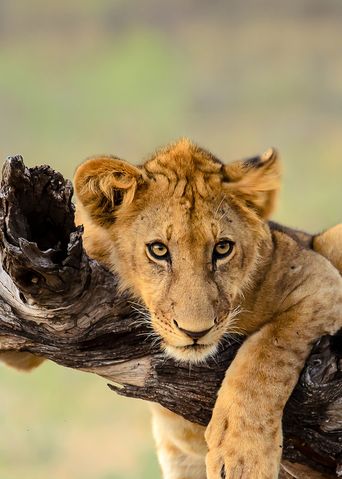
xmin=132 ymin=139 xmax=239 ymax=240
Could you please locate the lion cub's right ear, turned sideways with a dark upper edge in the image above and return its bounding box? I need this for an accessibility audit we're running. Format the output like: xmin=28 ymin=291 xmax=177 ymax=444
xmin=224 ymin=148 xmax=280 ymax=219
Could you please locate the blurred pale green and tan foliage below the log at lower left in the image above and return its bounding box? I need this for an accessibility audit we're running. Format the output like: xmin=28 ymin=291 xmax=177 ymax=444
xmin=0 ymin=363 xmax=158 ymax=479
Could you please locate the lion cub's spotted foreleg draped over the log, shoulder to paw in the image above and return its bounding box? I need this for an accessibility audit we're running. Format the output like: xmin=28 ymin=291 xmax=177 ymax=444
xmin=206 ymin=253 xmax=342 ymax=479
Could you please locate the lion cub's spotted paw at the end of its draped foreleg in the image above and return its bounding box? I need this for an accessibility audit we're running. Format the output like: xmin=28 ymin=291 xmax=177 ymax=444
xmin=205 ymin=408 xmax=282 ymax=479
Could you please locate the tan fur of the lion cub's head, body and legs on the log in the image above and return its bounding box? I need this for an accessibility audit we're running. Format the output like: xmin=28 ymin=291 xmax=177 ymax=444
xmin=75 ymin=139 xmax=342 ymax=479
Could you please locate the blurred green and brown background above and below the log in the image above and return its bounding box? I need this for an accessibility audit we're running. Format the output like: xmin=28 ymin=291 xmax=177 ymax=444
xmin=0 ymin=0 xmax=342 ymax=479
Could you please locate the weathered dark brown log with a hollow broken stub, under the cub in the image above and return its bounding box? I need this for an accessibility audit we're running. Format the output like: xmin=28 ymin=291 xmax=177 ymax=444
xmin=0 ymin=157 xmax=342 ymax=478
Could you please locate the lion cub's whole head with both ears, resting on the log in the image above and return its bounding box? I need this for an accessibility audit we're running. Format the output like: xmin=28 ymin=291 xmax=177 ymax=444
xmin=75 ymin=140 xmax=275 ymax=361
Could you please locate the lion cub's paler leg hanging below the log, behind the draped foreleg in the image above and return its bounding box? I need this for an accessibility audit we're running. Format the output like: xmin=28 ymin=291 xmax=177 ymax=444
xmin=152 ymin=405 xmax=207 ymax=479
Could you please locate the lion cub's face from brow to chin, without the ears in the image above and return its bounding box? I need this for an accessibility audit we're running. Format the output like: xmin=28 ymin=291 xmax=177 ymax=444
xmin=112 ymin=191 xmax=258 ymax=361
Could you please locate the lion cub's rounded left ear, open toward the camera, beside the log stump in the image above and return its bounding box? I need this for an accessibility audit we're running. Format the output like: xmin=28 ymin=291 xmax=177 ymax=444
xmin=74 ymin=156 xmax=142 ymax=226
